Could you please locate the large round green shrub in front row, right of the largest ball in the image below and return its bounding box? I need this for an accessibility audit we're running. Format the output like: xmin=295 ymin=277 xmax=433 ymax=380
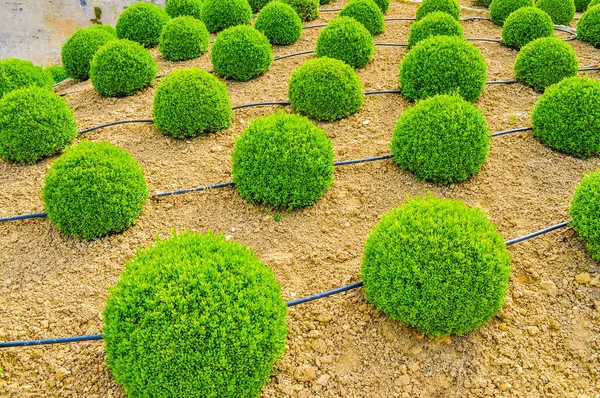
xmin=361 ymin=196 xmax=510 ymax=336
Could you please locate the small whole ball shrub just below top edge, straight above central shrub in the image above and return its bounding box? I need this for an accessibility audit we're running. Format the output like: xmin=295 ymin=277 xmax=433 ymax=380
xmin=254 ymin=1 xmax=302 ymax=46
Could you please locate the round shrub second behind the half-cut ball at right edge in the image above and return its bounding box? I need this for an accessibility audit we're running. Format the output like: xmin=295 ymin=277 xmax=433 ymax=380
xmin=515 ymin=37 xmax=579 ymax=92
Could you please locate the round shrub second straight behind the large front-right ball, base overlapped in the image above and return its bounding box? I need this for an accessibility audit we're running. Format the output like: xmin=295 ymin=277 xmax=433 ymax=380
xmin=400 ymin=36 xmax=487 ymax=102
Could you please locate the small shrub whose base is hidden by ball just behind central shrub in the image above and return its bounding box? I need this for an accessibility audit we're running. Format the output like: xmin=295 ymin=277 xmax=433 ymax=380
xmin=316 ymin=17 xmax=375 ymax=68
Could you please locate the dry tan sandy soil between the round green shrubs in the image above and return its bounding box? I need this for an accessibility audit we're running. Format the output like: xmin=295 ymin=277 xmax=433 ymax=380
xmin=0 ymin=0 xmax=600 ymax=398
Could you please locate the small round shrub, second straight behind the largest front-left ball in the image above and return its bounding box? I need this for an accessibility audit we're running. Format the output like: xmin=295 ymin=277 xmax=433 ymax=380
xmin=158 ymin=16 xmax=210 ymax=61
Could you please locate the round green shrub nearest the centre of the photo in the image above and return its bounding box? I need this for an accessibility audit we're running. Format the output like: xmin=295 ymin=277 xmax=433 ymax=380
xmin=232 ymin=112 xmax=333 ymax=210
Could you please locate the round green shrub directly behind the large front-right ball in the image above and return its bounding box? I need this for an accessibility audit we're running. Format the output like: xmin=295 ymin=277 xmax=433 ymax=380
xmin=392 ymin=95 xmax=491 ymax=184
